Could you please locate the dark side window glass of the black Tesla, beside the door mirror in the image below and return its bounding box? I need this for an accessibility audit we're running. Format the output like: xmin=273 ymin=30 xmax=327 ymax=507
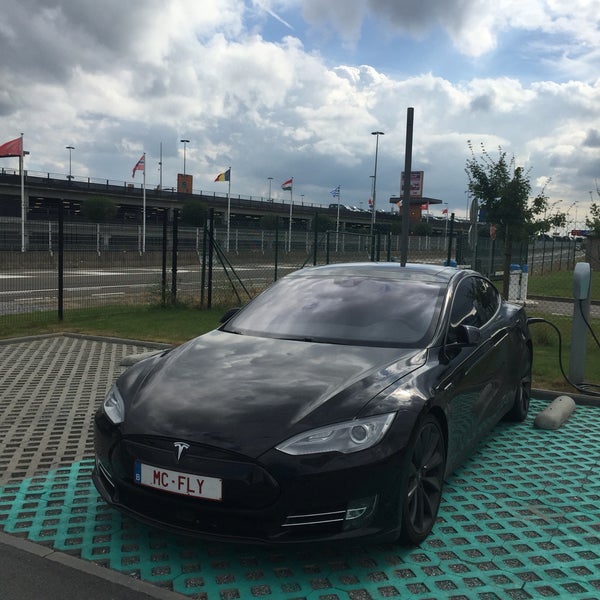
xmin=448 ymin=276 xmax=500 ymax=342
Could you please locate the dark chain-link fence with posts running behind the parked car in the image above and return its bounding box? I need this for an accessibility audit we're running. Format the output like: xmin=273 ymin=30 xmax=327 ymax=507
xmin=0 ymin=211 xmax=600 ymax=394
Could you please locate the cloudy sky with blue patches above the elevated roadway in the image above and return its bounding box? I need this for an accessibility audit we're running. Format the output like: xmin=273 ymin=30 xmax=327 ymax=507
xmin=0 ymin=0 xmax=600 ymax=226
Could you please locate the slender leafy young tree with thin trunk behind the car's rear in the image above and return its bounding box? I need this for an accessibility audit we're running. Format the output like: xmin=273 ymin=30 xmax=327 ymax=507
xmin=465 ymin=141 xmax=566 ymax=297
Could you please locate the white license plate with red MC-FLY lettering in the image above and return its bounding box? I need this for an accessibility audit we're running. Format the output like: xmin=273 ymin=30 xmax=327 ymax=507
xmin=134 ymin=461 xmax=223 ymax=500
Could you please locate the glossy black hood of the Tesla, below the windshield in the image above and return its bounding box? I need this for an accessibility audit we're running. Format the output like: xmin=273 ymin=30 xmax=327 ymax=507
xmin=118 ymin=330 xmax=425 ymax=457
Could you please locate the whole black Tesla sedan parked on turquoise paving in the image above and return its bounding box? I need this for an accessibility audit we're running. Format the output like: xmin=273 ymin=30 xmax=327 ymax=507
xmin=93 ymin=263 xmax=532 ymax=544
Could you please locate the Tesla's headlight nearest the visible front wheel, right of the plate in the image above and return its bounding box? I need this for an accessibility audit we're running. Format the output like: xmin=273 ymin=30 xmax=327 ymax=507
xmin=276 ymin=413 xmax=396 ymax=455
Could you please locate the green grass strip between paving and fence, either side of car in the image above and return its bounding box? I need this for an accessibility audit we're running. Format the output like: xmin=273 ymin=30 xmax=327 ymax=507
xmin=0 ymin=306 xmax=600 ymax=393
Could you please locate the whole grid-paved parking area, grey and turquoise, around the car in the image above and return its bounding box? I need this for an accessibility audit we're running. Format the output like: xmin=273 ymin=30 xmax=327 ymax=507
xmin=0 ymin=335 xmax=600 ymax=600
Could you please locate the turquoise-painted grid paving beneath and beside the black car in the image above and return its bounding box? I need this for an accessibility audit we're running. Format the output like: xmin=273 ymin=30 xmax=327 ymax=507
xmin=0 ymin=401 xmax=600 ymax=600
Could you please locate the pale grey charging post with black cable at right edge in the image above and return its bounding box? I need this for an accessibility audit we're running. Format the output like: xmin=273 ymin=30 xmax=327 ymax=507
xmin=569 ymin=262 xmax=592 ymax=384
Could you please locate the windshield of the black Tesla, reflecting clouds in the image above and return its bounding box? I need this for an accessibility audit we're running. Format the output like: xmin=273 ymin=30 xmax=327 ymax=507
xmin=223 ymin=275 xmax=445 ymax=348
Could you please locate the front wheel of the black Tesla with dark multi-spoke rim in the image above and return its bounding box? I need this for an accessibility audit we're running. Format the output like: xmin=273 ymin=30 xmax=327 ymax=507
xmin=399 ymin=415 xmax=446 ymax=546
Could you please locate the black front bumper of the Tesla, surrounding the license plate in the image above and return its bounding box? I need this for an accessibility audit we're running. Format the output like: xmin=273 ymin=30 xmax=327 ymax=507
xmin=92 ymin=420 xmax=401 ymax=544
